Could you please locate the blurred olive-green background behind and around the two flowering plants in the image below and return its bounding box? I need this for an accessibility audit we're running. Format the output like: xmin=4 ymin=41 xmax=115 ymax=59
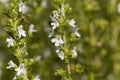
xmin=0 ymin=0 xmax=120 ymax=80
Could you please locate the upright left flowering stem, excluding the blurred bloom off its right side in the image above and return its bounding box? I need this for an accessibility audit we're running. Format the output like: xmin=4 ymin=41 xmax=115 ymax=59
xmin=6 ymin=0 xmax=28 ymax=80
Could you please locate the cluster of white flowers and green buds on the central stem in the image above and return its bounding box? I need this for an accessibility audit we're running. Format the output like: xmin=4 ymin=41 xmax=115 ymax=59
xmin=48 ymin=4 xmax=81 ymax=60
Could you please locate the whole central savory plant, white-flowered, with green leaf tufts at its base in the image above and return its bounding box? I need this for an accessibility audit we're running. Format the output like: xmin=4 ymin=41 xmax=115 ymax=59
xmin=48 ymin=0 xmax=83 ymax=80
